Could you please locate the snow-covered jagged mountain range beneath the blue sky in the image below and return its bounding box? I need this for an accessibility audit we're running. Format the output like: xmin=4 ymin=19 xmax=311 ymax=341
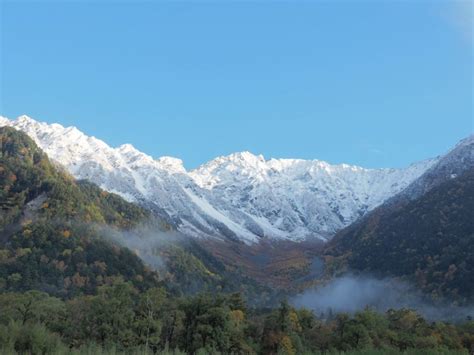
xmin=0 ymin=116 xmax=438 ymax=243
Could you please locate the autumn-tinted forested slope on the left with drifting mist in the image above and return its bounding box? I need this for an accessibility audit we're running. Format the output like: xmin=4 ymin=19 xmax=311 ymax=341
xmin=0 ymin=127 xmax=282 ymax=304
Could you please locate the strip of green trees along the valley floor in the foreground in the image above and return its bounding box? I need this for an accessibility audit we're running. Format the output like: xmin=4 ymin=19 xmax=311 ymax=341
xmin=0 ymin=281 xmax=474 ymax=354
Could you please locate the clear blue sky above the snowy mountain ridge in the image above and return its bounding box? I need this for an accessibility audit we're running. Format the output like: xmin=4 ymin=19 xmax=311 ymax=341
xmin=0 ymin=0 xmax=474 ymax=168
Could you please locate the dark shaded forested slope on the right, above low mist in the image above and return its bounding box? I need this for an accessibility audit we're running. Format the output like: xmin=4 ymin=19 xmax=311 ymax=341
xmin=327 ymin=167 xmax=474 ymax=302
